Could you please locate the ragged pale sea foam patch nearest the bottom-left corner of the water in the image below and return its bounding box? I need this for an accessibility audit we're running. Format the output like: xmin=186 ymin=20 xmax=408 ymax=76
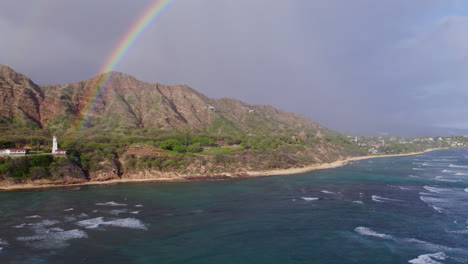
xmin=17 ymin=228 xmax=88 ymax=249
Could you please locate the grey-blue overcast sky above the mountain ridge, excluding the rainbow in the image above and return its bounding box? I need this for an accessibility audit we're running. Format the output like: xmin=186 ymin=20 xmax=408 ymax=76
xmin=0 ymin=0 xmax=468 ymax=135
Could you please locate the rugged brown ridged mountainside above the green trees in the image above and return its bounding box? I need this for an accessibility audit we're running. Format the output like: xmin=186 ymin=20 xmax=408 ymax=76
xmin=0 ymin=65 xmax=328 ymax=136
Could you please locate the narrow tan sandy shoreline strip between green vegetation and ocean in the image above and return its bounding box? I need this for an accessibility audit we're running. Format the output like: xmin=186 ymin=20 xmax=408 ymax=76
xmin=0 ymin=148 xmax=445 ymax=191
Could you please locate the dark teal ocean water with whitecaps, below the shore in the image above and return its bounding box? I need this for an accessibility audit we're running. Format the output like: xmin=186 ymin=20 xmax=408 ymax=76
xmin=0 ymin=150 xmax=468 ymax=264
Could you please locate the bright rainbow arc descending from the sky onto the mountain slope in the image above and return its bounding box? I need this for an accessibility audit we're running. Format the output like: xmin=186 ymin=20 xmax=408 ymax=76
xmin=74 ymin=0 xmax=173 ymax=132
